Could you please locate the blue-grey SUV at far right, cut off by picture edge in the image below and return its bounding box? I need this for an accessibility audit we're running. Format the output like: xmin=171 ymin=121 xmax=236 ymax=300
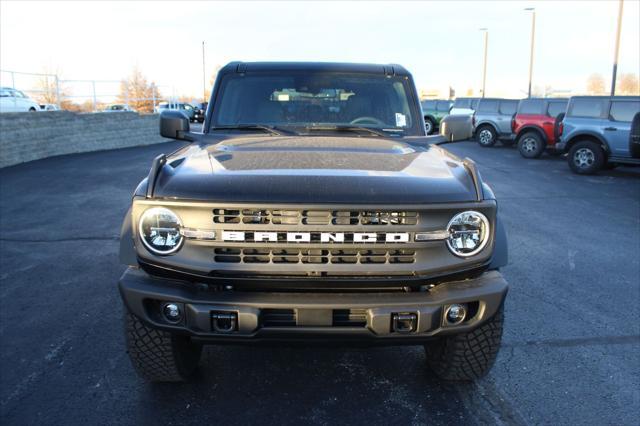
xmin=556 ymin=96 xmax=640 ymax=174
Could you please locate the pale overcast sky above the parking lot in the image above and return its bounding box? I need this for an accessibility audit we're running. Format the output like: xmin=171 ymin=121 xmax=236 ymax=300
xmin=0 ymin=0 xmax=640 ymax=96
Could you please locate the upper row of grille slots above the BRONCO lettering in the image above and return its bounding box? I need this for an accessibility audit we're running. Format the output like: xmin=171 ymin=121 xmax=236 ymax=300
xmin=213 ymin=209 xmax=418 ymax=226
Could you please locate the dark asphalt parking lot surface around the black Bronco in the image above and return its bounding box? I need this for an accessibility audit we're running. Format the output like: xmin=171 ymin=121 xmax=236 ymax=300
xmin=0 ymin=138 xmax=640 ymax=425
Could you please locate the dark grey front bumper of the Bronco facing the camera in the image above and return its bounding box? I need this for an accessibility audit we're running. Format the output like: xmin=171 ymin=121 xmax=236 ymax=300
xmin=119 ymin=268 xmax=508 ymax=345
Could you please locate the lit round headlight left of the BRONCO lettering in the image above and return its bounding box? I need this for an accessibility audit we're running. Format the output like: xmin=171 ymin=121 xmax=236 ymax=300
xmin=138 ymin=207 xmax=182 ymax=255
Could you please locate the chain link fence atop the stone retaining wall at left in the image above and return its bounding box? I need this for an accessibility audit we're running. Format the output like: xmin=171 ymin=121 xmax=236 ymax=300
xmin=0 ymin=70 xmax=179 ymax=113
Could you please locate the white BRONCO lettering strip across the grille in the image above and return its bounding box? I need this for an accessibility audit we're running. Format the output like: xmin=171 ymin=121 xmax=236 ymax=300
xmin=222 ymin=231 xmax=409 ymax=244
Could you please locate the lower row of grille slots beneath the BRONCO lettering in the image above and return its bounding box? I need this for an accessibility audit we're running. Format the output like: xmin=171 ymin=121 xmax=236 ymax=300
xmin=214 ymin=247 xmax=416 ymax=264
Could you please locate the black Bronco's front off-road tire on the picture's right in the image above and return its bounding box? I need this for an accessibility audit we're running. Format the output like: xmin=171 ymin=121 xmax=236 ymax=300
xmin=425 ymin=307 xmax=504 ymax=382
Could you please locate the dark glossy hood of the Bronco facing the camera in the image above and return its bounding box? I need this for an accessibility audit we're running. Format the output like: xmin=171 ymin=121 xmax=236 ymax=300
xmin=155 ymin=135 xmax=476 ymax=204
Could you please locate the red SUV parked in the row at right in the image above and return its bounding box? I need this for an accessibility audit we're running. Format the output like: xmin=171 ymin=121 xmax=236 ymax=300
xmin=511 ymin=98 xmax=569 ymax=158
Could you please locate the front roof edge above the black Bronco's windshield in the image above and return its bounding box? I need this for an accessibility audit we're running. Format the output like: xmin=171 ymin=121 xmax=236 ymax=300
xmin=221 ymin=62 xmax=410 ymax=76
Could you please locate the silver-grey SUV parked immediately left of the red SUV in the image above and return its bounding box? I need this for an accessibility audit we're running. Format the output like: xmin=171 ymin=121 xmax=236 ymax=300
xmin=473 ymin=98 xmax=519 ymax=147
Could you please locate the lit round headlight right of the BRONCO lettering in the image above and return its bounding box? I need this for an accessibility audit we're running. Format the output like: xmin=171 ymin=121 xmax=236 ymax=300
xmin=447 ymin=211 xmax=489 ymax=257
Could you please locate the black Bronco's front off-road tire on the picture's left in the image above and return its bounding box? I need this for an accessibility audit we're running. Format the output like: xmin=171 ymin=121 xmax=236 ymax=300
xmin=124 ymin=312 xmax=202 ymax=382
